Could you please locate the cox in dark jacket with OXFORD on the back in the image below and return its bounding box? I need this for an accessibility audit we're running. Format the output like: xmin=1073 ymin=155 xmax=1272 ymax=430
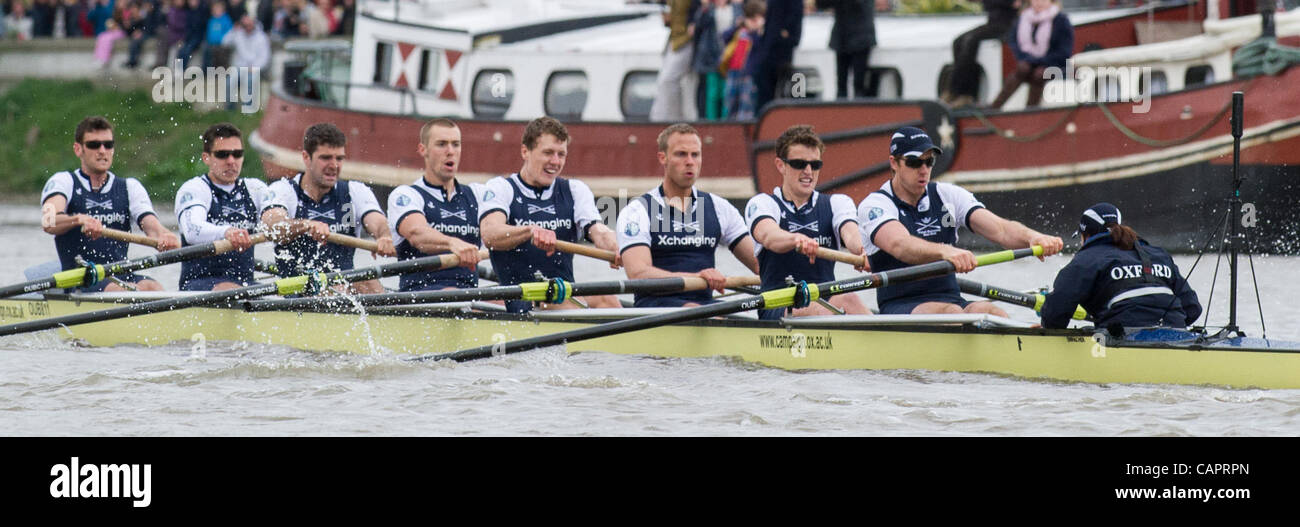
xmin=1043 ymin=203 xmax=1201 ymax=329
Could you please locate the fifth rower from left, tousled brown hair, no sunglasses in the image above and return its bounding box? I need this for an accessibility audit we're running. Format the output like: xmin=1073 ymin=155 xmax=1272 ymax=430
xmin=478 ymin=117 xmax=620 ymax=312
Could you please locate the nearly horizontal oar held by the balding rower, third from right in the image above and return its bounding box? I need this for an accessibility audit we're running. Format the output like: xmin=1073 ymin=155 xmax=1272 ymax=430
xmin=244 ymin=266 xmax=759 ymax=311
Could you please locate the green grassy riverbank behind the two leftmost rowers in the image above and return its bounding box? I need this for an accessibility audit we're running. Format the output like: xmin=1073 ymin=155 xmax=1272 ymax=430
xmin=0 ymin=79 xmax=263 ymax=203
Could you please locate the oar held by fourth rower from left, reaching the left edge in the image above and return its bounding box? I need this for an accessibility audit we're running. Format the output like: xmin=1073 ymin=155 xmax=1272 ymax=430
xmin=0 ymin=255 xmax=470 ymax=336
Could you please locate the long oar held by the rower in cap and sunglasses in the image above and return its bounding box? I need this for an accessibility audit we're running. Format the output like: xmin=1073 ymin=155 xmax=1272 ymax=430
xmin=416 ymin=246 xmax=1043 ymax=362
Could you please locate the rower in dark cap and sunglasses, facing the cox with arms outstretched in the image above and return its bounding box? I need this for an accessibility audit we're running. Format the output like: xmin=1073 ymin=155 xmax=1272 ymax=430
xmin=858 ymin=126 xmax=1063 ymax=316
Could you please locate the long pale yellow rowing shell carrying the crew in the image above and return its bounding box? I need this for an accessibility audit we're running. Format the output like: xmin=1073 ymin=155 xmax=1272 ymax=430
xmin=0 ymin=293 xmax=1300 ymax=388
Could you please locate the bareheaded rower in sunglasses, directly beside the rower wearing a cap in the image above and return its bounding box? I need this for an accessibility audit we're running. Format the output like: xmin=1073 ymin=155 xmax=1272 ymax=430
xmin=745 ymin=125 xmax=871 ymax=320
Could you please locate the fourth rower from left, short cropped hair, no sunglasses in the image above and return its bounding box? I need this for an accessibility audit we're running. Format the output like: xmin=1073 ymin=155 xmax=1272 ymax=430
xmin=389 ymin=118 xmax=482 ymax=291
